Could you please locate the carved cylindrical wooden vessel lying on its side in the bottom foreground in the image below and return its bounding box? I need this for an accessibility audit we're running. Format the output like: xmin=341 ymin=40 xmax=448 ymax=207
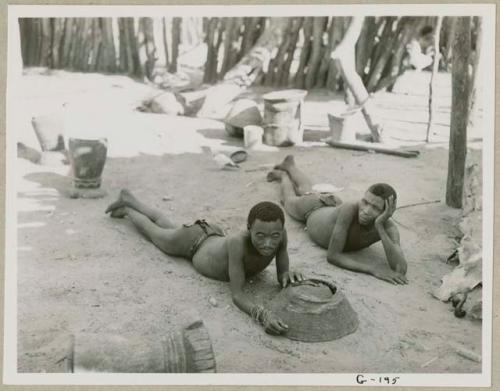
xmin=63 ymin=321 xmax=216 ymax=373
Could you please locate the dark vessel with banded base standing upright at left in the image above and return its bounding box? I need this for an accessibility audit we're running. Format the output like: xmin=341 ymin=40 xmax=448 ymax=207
xmin=68 ymin=138 xmax=108 ymax=189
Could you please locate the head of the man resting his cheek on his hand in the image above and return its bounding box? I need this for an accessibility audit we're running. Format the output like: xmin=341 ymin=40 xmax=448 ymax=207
xmin=358 ymin=183 xmax=397 ymax=225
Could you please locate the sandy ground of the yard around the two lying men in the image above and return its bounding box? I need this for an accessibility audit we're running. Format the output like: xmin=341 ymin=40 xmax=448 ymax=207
xmin=9 ymin=71 xmax=481 ymax=373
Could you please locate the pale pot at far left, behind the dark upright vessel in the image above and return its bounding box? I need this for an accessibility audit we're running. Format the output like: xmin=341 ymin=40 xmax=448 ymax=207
xmin=31 ymin=115 xmax=64 ymax=152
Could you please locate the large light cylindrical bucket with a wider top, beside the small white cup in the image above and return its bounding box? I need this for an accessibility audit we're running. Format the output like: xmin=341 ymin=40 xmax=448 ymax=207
xmin=262 ymin=90 xmax=307 ymax=146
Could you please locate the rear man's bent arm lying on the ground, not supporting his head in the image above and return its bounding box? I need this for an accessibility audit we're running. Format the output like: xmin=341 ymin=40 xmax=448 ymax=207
xmin=326 ymin=204 xmax=374 ymax=274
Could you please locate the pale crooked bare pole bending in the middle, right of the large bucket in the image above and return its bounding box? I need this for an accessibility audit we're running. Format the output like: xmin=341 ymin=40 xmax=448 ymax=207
xmin=332 ymin=16 xmax=382 ymax=142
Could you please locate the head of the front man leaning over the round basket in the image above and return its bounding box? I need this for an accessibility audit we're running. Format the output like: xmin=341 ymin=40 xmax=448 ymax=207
xmin=247 ymin=201 xmax=285 ymax=256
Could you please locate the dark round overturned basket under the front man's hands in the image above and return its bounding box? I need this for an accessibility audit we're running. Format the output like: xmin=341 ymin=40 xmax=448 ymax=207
xmin=269 ymin=279 xmax=359 ymax=342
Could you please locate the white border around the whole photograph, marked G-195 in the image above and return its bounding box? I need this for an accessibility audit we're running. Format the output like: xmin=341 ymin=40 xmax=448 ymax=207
xmin=3 ymin=3 xmax=496 ymax=387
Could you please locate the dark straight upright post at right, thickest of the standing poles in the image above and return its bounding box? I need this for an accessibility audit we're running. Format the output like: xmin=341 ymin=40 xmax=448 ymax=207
xmin=446 ymin=17 xmax=471 ymax=208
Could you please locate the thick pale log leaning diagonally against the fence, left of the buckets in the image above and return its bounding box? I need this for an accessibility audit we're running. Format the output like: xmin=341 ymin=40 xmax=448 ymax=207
xmin=197 ymin=18 xmax=287 ymax=117
